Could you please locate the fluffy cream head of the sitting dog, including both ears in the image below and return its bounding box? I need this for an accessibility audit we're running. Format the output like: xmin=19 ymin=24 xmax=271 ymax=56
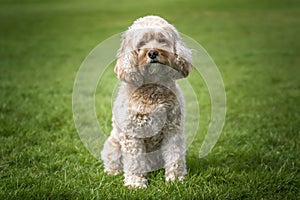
xmin=114 ymin=16 xmax=192 ymax=82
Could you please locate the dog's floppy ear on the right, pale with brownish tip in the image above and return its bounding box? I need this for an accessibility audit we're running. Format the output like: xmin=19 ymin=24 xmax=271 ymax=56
xmin=175 ymin=35 xmax=192 ymax=78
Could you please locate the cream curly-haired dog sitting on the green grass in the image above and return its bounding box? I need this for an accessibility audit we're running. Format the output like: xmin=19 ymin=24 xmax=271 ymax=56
xmin=101 ymin=16 xmax=192 ymax=188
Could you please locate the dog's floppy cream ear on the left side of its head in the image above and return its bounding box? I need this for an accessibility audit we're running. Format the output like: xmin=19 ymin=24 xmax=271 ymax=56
xmin=114 ymin=31 xmax=137 ymax=81
